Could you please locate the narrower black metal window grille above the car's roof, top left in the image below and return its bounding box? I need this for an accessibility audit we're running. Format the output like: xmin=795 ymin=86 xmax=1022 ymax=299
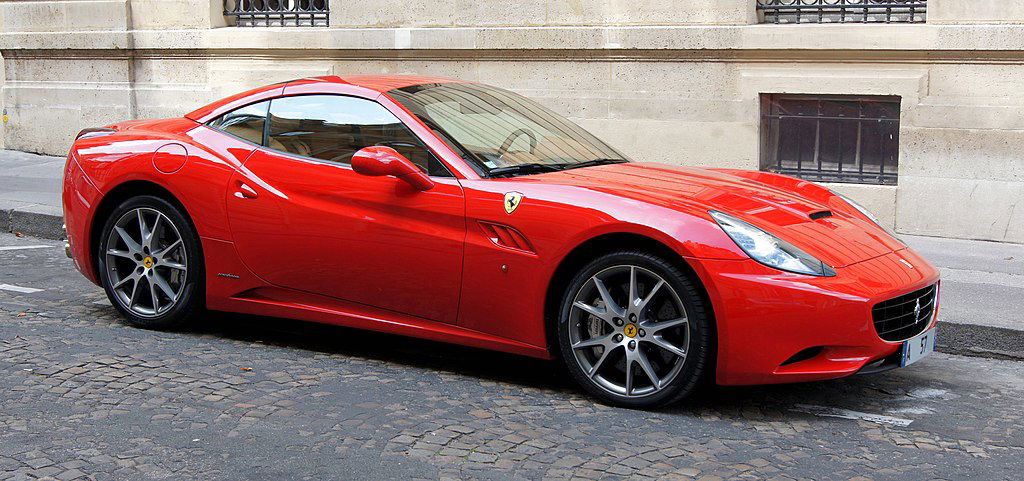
xmin=224 ymin=0 xmax=329 ymax=27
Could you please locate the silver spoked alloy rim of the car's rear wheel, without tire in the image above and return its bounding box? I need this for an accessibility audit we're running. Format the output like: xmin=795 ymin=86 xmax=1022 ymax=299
xmin=104 ymin=207 xmax=188 ymax=318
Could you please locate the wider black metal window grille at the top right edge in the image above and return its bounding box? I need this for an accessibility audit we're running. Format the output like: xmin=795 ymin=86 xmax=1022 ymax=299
xmin=758 ymin=0 xmax=928 ymax=24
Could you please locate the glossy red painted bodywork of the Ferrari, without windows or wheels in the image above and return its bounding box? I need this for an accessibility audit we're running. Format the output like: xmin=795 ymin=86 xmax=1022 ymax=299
xmin=63 ymin=76 xmax=938 ymax=384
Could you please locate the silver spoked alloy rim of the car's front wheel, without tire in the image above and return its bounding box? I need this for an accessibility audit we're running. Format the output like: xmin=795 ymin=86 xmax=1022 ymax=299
xmin=568 ymin=265 xmax=689 ymax=397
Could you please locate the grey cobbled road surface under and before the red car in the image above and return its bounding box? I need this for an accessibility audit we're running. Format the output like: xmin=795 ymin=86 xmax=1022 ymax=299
xmin=0 ymin=234 xmax=1024 ymax=480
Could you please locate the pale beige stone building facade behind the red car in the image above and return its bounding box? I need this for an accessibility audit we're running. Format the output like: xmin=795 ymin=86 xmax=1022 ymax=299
xmin=0 ymin=0 xmax=1024 ymax=243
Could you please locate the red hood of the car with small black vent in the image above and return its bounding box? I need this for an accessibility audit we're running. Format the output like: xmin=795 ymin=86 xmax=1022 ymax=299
xmin=519 ymin=163 xmax=904 ymax=267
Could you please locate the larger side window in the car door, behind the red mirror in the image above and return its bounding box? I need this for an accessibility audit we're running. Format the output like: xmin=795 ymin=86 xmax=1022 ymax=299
xmin=267 ymin=95 xmax=452 ymax=177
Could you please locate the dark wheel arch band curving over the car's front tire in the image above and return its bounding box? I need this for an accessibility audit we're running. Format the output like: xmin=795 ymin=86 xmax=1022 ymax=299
xmin=544 ymin=232 xmax=718 ymax=362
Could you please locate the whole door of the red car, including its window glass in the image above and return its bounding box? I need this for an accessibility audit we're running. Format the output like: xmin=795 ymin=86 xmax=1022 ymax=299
xmin=227 ymin=94 xmax=466 ymax=322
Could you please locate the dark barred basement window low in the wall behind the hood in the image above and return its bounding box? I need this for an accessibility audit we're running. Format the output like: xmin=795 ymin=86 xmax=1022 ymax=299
xmin=761 ymin=94 xmax=900 ymax=185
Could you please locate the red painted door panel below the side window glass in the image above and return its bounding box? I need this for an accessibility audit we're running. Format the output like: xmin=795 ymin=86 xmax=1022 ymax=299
xmin=226 ymin=148 xmax=466 ymax=322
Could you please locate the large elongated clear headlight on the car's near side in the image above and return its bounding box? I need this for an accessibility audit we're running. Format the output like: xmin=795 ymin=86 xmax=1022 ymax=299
xmin=708 ymin=211 xmax=836 ymax=276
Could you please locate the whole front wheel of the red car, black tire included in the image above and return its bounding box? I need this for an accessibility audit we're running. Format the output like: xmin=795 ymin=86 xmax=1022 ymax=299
xmin=558 ymin=251 xmax=712 ymax=407
